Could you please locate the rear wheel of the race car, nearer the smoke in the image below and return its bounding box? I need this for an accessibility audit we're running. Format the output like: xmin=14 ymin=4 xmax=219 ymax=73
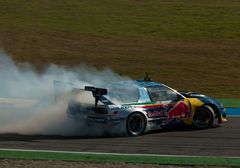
xmin=127 ymin=112 xmax=146 ymax=136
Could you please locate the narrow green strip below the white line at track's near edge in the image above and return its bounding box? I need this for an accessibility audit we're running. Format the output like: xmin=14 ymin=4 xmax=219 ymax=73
xmin=0 ymin=150 xmax=240 ymax=167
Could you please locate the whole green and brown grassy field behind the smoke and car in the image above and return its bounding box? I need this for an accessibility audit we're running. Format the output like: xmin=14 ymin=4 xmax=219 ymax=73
xmin=0 ymin=0 xmax=240 ymax=98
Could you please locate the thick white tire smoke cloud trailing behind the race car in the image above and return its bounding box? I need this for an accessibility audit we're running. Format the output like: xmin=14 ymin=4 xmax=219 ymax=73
xmin=0 ymin=51 xmax=128 ymax=136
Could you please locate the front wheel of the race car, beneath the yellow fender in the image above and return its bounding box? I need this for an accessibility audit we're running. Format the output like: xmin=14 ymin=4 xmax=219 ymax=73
xmin=192 ymin=105 xmax=215 ymax=129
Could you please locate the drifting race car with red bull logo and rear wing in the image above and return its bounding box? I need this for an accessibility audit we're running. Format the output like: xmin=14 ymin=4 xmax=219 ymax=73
xmin=67 ymin=77 xmax=227 ymax=136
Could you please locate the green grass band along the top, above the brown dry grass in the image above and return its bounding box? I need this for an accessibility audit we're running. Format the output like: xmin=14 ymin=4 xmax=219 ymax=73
xmin=0 ymin=0 xmax=240 ymax=39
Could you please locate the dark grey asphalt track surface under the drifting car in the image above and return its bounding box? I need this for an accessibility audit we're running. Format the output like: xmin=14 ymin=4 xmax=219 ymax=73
xmin=0 ymin=117 xmax=240 ymax=157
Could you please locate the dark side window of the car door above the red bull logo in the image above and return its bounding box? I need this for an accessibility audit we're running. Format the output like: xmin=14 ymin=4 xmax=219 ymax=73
xmin=147 ymin=86 xmax=178 ymax=101
